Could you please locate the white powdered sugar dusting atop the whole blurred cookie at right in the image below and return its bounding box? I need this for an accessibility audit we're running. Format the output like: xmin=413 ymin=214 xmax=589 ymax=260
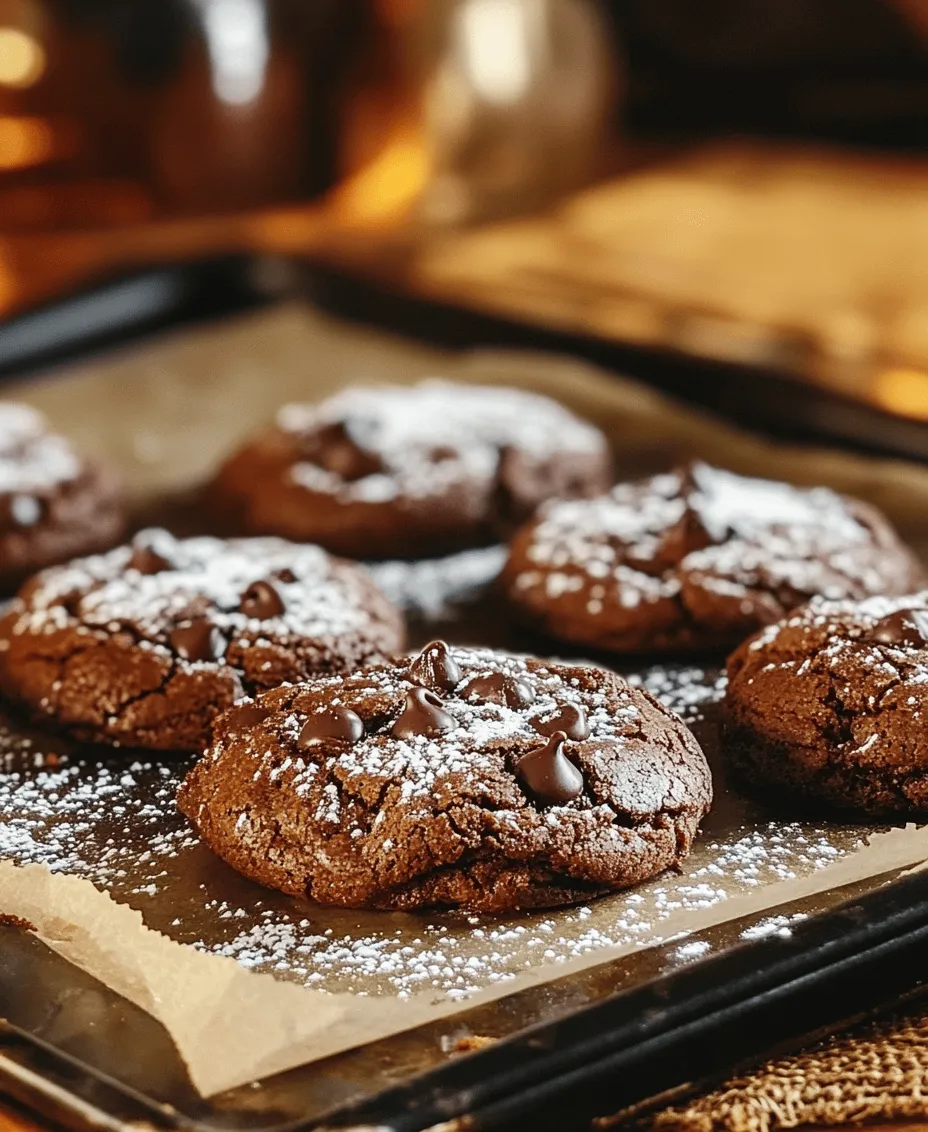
xmin=510 ymin=463 xmax=917 ymax=638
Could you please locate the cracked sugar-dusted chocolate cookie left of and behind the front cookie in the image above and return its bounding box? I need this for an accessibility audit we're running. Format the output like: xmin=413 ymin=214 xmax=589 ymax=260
xmin=0 ymin=531 xmax=403 ymax=751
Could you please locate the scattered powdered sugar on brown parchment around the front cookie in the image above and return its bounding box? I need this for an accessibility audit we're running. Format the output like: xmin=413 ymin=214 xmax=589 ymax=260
xmin=0 ymin=667 xmax=870 ymax=998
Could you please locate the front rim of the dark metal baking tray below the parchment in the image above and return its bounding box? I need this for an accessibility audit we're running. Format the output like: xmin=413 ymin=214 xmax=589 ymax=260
xmin=0 ymin=267 xmax=928 ymax=1132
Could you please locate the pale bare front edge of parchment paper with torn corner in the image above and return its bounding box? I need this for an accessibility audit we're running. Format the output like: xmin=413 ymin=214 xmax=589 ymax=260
xmin=0 ymin=826 xmax=928 ymax=1097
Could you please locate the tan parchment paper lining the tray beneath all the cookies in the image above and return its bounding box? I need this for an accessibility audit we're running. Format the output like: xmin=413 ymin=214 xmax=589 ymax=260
xmin=0 ymin=310 xmax=928 ymax=1110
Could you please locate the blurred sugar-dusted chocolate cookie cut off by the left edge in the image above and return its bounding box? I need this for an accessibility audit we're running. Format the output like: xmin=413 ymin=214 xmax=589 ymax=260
xmin=0 ymin=402 xmax=124 ymax=592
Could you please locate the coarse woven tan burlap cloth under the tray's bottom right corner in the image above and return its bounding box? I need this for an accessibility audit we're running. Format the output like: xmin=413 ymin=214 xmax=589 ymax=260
xmin=642 ymin=1014 xmax=928 ymax=1132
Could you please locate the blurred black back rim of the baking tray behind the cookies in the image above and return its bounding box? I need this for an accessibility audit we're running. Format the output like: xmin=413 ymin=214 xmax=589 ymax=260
xmin=0 ymin=255 xmax=928 ymax=461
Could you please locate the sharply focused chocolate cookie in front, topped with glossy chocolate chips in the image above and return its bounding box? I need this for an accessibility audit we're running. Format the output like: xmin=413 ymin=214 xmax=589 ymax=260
xmin=179 ymin=641 xmax=712 ymax=911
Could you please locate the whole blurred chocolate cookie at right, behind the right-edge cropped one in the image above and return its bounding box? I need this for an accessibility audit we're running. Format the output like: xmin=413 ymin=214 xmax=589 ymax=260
xmin=502 ymin=463 xmax=925 ymax=652
